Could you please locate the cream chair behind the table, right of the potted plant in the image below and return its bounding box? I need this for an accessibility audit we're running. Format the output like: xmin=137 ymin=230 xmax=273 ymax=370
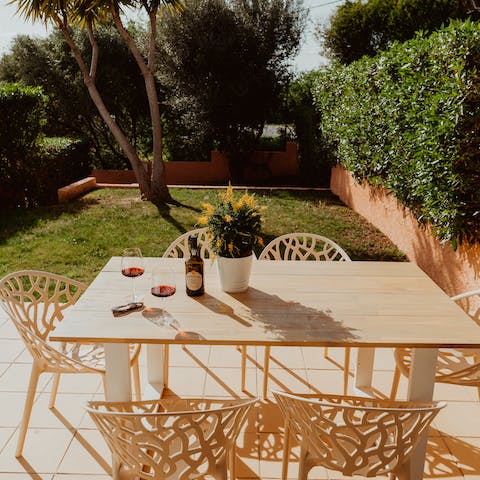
xmin=256 ymin=233 xmax=351 ymax=398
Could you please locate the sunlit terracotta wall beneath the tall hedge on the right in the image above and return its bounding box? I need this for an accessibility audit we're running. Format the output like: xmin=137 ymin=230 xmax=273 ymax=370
xmin=331 ymin=167 xmax=480 ymax=308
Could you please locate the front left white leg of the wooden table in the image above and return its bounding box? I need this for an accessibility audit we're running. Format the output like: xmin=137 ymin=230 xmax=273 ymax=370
xmin=104 ymin=343 xmax=132 ymax=480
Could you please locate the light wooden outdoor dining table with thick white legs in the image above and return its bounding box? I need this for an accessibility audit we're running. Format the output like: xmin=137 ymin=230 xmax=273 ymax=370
xmin=50 ymin=257 xmax=480 ymax=480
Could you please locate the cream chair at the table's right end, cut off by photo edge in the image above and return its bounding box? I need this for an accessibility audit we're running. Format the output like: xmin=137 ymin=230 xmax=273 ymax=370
xmin=390 ymin=290 xmax=480 ymax=399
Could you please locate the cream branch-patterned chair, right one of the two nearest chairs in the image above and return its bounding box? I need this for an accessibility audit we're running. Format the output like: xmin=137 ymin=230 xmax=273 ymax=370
xmin=273 ymin=391 xmax=445 ymax=480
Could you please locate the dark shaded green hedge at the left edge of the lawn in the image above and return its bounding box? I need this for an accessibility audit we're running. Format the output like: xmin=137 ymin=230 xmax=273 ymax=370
xmin=0 ymin=84 xmax=91 ymax=208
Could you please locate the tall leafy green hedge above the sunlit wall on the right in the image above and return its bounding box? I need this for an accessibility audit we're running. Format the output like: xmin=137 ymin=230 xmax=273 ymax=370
xmin=314 ymin=21 xmax=480 ymax=247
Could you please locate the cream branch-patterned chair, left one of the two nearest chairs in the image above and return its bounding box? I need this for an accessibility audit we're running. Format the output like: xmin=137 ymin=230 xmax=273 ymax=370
xmin=87 ymin=398 xmax=257 ymax=480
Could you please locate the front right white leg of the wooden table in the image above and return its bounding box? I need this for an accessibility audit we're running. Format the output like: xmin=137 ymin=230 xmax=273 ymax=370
xmin=407 ymin=348 xmax=438 ymax=480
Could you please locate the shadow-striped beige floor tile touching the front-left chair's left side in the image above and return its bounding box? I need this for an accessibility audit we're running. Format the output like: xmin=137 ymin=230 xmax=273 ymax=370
xmin=57 ymin=429 xmax=111 ymax=475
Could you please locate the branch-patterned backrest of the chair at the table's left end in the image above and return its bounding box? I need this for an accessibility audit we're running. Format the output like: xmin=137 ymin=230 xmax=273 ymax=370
xmin=0 ymin=270 xmax=86 ymax=340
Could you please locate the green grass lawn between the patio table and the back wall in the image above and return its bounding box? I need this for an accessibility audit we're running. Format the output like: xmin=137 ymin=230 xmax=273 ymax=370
xmin=0 ymin=189 xmax=406 ymax=282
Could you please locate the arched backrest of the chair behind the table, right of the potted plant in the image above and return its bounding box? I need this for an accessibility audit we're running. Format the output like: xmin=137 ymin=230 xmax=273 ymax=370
xmin=259 ymin=233 xmax=350 ymax=262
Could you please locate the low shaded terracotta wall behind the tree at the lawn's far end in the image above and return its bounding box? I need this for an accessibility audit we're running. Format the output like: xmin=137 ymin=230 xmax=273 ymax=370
xmin=92 ymin=142 xmax=298 ymax=185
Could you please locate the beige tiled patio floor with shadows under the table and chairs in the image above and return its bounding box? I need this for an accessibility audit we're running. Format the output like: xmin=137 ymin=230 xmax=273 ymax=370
xmin=0 ymin=310 xmax=480 ymax=480
